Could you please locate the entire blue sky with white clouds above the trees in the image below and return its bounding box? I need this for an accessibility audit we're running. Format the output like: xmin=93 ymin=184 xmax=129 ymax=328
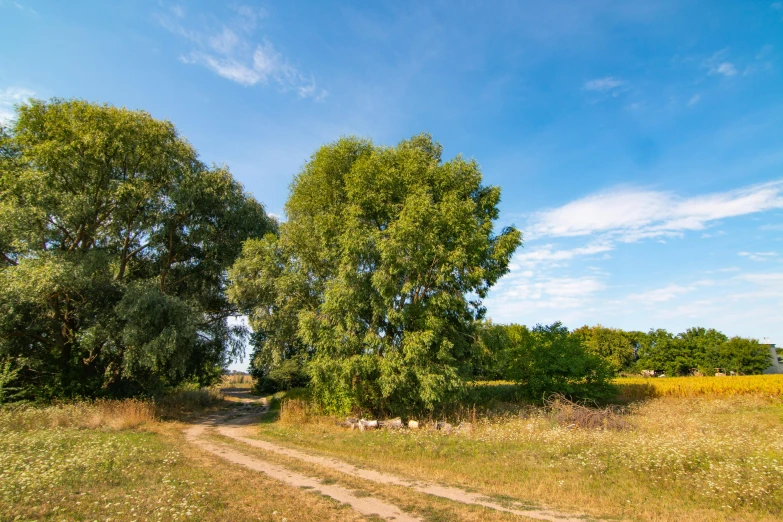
xmin=0 ymin=0 xmax=783 ymax=368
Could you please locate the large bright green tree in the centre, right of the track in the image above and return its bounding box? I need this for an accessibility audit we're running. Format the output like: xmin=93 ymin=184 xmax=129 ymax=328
xmin=231 ymin=135 xmax=521 ymax=411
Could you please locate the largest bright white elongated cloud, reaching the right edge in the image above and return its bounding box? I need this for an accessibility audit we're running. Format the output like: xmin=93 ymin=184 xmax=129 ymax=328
xmin=527 ymin=181 xmax=783 ymax=241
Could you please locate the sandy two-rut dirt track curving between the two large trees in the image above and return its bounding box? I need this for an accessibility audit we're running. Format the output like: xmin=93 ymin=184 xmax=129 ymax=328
xmin=186 ymin=389 xmax=608 ymax=522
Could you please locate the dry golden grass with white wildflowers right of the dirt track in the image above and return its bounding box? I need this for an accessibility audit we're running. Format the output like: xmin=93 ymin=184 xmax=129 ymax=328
xmin=257 ymin=378 xmax=783 ymax=522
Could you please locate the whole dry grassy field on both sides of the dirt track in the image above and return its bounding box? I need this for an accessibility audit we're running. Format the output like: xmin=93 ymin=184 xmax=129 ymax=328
xmin=0 ymin=376 xmax=783 ymax=522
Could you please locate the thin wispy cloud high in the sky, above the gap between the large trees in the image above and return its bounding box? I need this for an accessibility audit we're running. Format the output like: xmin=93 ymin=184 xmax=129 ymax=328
xmin=156 ymin=5 xmax=327 ymax=100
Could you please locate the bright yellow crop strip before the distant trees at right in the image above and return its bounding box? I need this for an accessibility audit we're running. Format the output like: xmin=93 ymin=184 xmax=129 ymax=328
xmin=614 ymin=375 xmax=783 ymax=399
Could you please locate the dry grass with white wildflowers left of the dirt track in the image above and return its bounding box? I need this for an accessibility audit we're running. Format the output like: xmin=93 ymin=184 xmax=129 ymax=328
xmin=0 ymin=392 xmax=363 ymax=522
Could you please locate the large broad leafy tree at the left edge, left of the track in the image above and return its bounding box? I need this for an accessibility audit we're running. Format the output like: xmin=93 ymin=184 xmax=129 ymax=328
xmin=0 ymin=99 xmax=276 ymax=396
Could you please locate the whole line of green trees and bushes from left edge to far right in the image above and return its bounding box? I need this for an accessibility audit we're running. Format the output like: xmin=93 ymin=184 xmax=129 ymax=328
xmin=0 ymin=99 xmax=772 ymax=413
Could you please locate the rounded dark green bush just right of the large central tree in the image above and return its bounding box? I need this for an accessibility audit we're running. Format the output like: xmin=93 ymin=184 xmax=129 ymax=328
xmin=506 ymin=323 xmax=615 ymax=400
